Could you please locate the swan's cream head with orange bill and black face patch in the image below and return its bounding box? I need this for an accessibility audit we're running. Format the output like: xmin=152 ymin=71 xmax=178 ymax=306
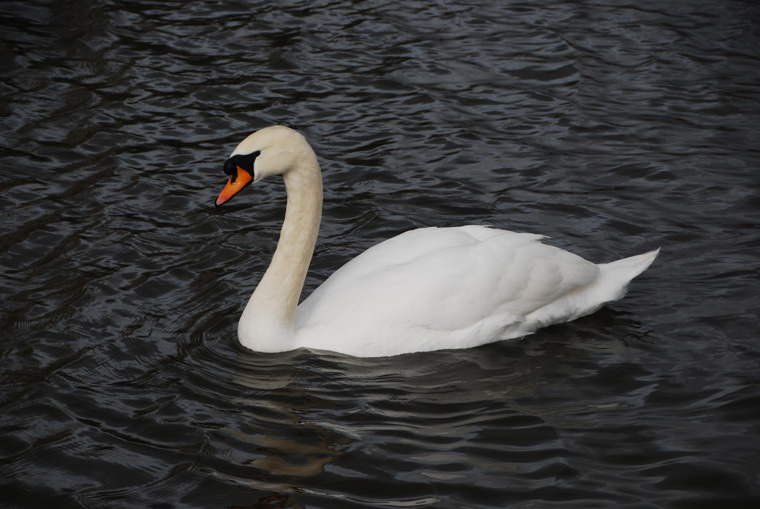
xmin=216 ymin=125 xmax=316 ymax=207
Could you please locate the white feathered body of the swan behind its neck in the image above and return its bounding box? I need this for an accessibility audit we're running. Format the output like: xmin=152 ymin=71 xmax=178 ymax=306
xmin=296 ymin=226 xmax=656 ymax=357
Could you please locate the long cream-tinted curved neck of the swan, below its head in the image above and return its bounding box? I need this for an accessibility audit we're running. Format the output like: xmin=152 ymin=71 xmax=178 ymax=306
xmin=238 ymin=150 xmax=322 ymax=352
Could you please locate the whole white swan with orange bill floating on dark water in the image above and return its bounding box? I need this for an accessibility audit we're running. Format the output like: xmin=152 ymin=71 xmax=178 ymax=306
xmin=216 ymin=126 xmax=659 ymax=357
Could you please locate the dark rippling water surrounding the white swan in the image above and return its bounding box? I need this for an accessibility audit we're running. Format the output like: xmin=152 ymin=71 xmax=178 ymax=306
xmin=0 ymin=0 xmax=760 ymax=508
